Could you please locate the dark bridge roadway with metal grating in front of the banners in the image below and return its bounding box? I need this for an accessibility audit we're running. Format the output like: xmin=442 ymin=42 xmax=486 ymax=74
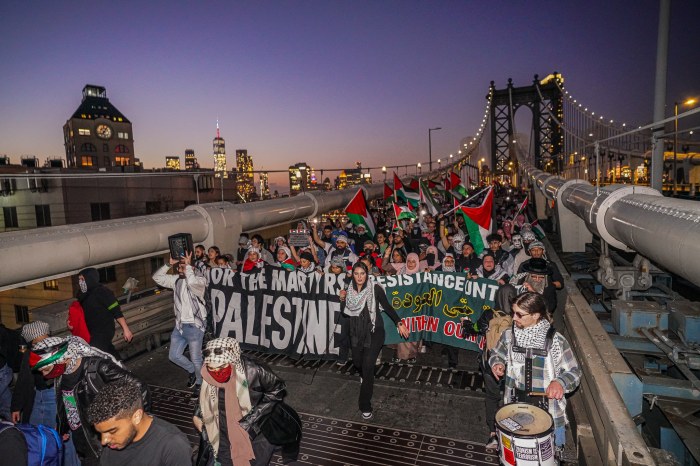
xmin=127 ymin=346 xmax=498 ymax=465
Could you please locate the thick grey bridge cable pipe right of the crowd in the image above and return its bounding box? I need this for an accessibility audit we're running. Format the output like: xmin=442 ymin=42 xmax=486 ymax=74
xmin=526 ymin=168 xmax=700 ymax=286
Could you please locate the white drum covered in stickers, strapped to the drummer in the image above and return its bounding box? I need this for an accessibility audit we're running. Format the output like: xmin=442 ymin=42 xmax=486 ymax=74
xmin=496 ymin=403 xmax=556 ymax=466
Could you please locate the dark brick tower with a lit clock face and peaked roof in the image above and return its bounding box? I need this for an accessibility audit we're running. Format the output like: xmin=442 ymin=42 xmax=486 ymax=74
xmin=63 ymin=84 xmax=136 ymax=168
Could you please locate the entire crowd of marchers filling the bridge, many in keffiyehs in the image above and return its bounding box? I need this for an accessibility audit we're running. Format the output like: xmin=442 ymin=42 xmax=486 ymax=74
xmin=0 ymin=180 xmax=581 ymax=466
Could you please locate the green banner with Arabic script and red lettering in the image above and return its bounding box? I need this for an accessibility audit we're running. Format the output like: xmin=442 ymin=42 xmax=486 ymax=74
xmin=377 ymin=272 xmax=498 ymax=351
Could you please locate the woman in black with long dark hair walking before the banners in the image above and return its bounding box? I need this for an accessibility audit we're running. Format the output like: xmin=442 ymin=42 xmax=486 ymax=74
xmin=339 ymin=262 xmax=410 ymax=420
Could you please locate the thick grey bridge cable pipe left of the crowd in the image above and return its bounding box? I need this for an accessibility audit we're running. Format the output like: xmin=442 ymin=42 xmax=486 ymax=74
xmin=0 ymin=183 xmax=384 ymax=291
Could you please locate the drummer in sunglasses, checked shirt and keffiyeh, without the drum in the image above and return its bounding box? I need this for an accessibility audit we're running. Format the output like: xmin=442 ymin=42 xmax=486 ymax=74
xmin=489 ymin=292 xmax=581 ymax=449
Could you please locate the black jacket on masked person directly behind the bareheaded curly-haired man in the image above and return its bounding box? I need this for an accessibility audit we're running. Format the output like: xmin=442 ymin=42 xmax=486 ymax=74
xmin=55 ymin=356 xmax=151 ymax=458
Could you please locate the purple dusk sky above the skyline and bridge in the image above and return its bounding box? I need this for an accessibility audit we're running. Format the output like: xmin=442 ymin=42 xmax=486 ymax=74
xmin=0 ymin=0 xmax=700 ymax=191
